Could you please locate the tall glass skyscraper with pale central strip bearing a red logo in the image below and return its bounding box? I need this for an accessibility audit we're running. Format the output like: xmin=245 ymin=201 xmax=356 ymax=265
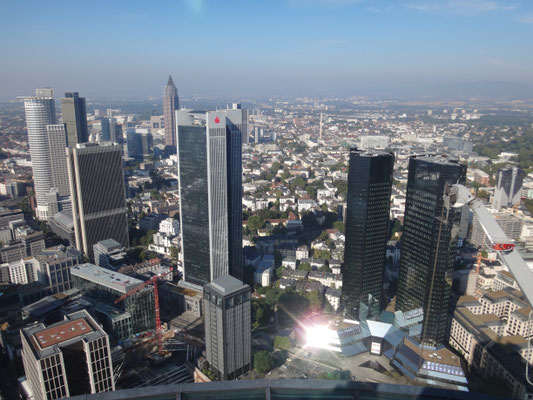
xmin=176 ymin=110 xmax=242 ymax=286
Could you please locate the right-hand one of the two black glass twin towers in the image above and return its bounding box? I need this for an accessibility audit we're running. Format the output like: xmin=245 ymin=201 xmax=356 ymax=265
xmin=396 ymin=156 xmax=466 ymax=345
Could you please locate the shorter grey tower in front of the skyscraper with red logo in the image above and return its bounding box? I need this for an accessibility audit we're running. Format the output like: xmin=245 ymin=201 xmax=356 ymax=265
xmin=204 ymin=275 xmax=252 ymax=380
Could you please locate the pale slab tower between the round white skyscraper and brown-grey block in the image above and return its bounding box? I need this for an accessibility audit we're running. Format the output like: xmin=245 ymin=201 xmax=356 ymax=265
xmin=46 ymin=124 xmax=70 ymax=196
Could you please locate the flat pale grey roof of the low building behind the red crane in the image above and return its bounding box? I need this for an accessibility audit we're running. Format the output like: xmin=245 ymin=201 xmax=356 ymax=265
xmin=70 ymin=263 xmax=143 ymax=294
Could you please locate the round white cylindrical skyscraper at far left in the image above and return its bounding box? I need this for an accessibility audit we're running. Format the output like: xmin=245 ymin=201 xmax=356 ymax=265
xmin=24 ymin=88 xmax=56 ymax=220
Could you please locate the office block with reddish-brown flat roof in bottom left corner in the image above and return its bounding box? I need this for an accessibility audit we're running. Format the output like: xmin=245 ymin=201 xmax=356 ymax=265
xmin=20 ymin=310 xmax=115 ymax=400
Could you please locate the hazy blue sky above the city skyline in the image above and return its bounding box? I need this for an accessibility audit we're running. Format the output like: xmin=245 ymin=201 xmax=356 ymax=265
xmin=0 ymin=0 xmax=533 ymax=98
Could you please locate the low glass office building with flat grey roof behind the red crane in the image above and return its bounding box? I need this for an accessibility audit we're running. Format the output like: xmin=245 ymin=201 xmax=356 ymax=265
xmin=70 ymin=263 xmax=155 ymax=333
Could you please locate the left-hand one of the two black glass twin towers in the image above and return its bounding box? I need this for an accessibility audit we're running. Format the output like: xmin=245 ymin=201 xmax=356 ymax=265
xmin=342 ymin=148 xmax=394 ymax=319
